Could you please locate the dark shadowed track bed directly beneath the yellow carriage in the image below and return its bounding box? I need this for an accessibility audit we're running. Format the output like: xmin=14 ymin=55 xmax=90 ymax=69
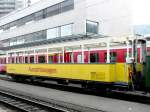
xmin=2 ymin=74 xmax=150 ymax=104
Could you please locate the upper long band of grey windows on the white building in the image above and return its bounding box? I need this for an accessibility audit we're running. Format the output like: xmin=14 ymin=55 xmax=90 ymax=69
xmin=0 ymin=0 xmax=74 ymax=30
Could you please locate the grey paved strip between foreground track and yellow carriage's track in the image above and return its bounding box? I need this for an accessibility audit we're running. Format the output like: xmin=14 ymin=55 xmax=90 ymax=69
xmin=0 ymin=80 xmax=150 ymax=112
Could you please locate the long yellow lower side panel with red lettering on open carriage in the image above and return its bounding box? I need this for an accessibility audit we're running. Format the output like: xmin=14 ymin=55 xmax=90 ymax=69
xmin=7 ymin=64 xmax=116 ymax=82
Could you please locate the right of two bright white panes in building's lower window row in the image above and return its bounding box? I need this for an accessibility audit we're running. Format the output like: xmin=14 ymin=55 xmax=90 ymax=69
xmin=61 ymin=24 xmax=73 ymax=37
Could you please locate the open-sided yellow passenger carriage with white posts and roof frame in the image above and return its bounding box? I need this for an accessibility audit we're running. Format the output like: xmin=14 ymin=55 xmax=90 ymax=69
xmin=2 ymin=38 xmax=142 ymax=87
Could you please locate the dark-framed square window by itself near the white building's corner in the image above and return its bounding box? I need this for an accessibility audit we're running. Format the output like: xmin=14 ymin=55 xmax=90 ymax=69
xmin=86 ymin=20 xmax=98 ymax=34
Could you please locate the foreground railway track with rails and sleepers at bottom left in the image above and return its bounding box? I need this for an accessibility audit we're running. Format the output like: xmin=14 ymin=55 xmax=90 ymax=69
xmin=0 ymin=87 xmax=103 ymax=112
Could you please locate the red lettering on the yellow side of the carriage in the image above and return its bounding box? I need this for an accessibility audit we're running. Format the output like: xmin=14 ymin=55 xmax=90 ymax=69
xmin=28 ymin=67 xmax=56 ymax=74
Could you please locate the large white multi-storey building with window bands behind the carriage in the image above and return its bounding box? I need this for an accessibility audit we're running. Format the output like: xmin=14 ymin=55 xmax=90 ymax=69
xmin=0 ymin=0 xmax=133 ymax=62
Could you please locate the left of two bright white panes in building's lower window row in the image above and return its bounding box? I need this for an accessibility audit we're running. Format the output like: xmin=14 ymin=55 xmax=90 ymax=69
xmin=47 ymin=27 xmax=59 ymax=39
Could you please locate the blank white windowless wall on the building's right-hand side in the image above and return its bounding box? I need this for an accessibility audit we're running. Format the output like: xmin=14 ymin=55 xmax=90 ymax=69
xmin=86 ymin=0 xmax=132 ymax=36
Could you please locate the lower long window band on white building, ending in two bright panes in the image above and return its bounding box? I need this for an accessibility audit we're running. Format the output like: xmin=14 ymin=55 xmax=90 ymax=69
xmin=5 ymin=24 xmax=73 ymax=47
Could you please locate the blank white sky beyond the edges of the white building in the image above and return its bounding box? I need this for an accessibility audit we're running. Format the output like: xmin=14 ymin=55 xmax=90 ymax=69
xmin=31 ymin=0 xmax=150 ymax=25
